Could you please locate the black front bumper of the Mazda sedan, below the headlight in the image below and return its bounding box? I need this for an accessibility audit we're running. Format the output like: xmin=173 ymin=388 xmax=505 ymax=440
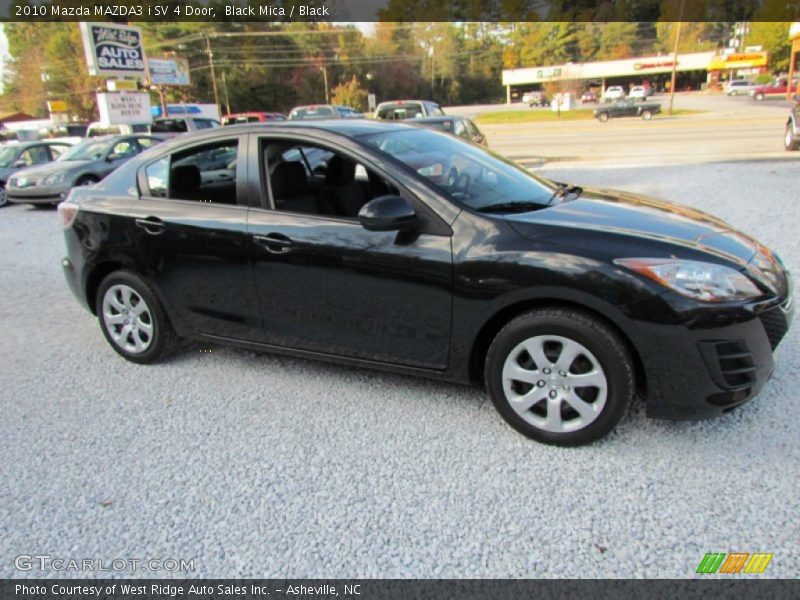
xmin=638 ymin=295 xmax=794 ymax=420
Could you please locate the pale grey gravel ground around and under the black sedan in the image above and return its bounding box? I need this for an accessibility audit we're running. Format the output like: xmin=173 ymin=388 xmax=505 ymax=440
xmin=0 ymin=162 xmax=800 ymax=577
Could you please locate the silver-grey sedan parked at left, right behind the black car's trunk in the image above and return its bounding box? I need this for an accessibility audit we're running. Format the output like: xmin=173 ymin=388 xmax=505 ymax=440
xmin=6 ymin=135 xmax=163 ymax=204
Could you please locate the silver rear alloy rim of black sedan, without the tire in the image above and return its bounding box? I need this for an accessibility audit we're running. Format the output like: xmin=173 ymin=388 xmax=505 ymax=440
xmin=102 ymin=284 xmax=154 ymax=354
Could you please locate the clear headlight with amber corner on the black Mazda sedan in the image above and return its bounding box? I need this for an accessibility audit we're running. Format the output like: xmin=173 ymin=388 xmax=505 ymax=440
xmin=614 ymin=258 xmax=761 ymax=302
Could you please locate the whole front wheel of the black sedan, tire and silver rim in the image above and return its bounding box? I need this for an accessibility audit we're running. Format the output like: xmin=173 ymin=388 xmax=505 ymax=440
xmin=485 ymin=308 xmax=635 ymax=446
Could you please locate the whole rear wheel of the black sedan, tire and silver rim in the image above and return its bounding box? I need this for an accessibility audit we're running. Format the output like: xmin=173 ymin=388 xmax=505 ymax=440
xmin=95 ymin=271 xmax=177 ymax=364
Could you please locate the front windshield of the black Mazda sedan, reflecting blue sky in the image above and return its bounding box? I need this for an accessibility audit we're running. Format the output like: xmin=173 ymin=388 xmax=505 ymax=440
xmin=359 ymin=128 xmax=558 ymax=211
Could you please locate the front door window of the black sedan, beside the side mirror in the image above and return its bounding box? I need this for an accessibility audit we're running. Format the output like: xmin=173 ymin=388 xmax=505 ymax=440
xmin=261 ymin=140 xmax=397 ymax=220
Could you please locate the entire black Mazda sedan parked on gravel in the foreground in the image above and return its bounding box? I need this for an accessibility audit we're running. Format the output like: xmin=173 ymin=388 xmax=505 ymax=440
xmin=60 ymin=120 xmax=792 ymax=445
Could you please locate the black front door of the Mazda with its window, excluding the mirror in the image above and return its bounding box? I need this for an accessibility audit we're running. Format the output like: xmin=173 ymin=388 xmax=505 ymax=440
xmin=248 ymin=138 xmax=452 ymax=369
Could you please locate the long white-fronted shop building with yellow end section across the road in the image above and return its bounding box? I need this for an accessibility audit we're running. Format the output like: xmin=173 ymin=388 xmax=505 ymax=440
xmin=503 ymin=51 xmax=767 ymax=103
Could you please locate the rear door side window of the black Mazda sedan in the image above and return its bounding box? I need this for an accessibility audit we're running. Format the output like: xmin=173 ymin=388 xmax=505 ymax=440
xmin=145 ymin=140 xmax=239 ymax=204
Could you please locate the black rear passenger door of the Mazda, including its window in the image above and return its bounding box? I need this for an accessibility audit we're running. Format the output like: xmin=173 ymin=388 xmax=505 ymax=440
xmin=129 ymin=135 xmax=262 ymax=341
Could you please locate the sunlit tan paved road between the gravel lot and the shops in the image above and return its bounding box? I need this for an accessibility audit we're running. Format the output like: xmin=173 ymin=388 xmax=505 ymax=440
xmin=445 ymin=94 xmax=800 ymax=166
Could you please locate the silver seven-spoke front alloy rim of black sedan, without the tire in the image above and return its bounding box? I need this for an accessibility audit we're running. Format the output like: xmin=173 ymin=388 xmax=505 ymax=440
xmin=502 ymin=335 xmax=608 ymax=433
